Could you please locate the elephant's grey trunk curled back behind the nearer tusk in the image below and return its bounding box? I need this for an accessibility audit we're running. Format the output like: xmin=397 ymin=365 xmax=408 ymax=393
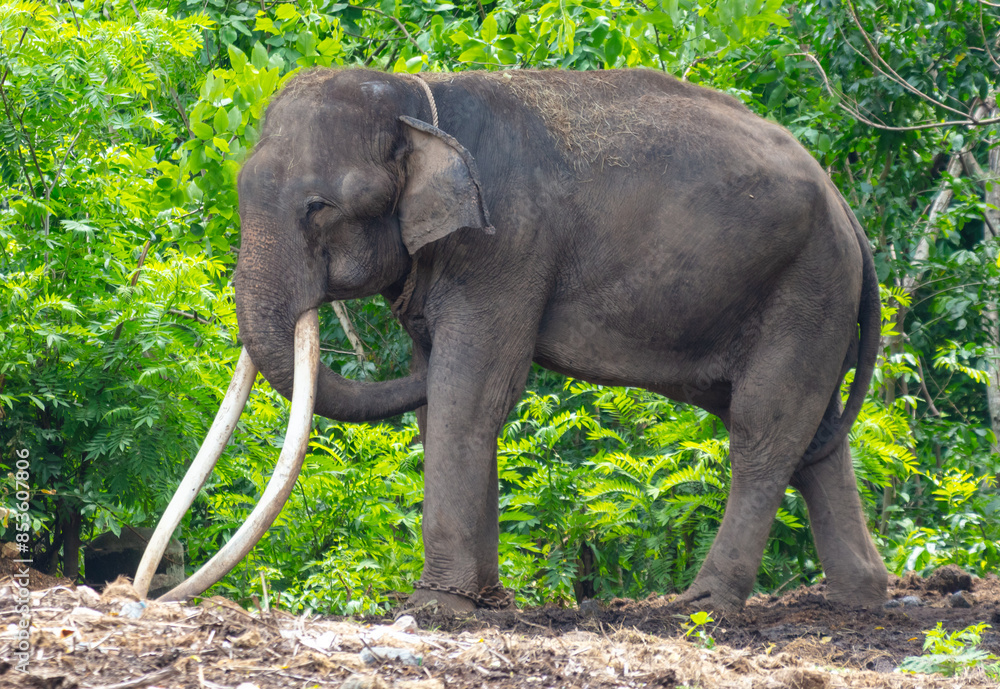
xmin=233 ymin=214 xmax=427 ymax=422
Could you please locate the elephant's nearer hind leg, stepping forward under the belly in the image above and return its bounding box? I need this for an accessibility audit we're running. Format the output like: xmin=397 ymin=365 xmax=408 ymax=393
xmin=679 ymin=288 xmax=850 ymax=612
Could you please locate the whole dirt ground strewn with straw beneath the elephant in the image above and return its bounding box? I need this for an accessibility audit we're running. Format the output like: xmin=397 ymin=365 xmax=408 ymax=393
xmin=0 ymin=570 xmax=1000 ymax=689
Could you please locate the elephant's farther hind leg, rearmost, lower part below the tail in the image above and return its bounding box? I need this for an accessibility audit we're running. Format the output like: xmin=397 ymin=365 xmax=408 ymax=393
xmin=791 ymin=440 xmax=889 ymax=607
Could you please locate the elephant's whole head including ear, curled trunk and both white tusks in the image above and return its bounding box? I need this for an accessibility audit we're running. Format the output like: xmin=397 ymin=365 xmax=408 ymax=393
xmin=135 ymin=70 xmax=492 ymax=600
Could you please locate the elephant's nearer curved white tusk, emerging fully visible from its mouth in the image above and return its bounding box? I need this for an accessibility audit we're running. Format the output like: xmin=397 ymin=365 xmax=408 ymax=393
xmin=158 ymin=309 xmax=319 ymax=601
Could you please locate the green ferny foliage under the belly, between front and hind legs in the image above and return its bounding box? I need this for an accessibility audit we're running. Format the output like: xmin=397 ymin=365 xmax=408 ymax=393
xmin=498 ymin=381 xmax=729 ymax=603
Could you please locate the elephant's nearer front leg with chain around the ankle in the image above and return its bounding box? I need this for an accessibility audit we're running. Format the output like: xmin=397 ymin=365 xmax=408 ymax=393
xmin=409 ymin=332 xmax=532 ymax=611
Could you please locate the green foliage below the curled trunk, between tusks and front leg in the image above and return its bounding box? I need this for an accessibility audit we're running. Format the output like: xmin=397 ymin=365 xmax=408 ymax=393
xmin=190 ymin=416 xmax=423 ymax=615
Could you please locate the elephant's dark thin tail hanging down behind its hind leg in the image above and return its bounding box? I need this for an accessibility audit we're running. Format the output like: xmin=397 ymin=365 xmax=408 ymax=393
xmin=802 ymin=192 xmax=882 ymax=465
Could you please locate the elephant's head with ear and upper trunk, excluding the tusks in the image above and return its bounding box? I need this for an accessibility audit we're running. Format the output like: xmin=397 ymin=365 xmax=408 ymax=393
xmin=234 ymin=71 xmax=489 ymax=420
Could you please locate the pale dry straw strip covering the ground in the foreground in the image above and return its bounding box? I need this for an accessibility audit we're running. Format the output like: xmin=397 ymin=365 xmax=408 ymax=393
xmin=0 ymin=583 xmax=989 ymax=689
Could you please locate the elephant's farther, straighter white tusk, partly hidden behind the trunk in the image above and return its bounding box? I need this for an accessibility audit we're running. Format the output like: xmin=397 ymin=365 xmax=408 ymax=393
xmin=133 ymin=347 xmax=257 ymax=597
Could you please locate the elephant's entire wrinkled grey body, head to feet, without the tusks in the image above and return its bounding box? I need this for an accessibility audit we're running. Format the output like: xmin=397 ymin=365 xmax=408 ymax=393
xmin=235 ymin=70 xmax=887 ymax=611
